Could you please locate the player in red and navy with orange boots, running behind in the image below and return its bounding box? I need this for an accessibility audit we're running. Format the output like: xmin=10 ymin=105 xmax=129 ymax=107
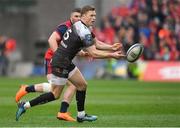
xmin=15 ymin=8 xmax=82 ymax=121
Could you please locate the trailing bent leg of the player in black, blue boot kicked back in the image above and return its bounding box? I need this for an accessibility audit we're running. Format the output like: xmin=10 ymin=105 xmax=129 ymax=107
xmin=16 ymin=67 xmax=74 ymax=120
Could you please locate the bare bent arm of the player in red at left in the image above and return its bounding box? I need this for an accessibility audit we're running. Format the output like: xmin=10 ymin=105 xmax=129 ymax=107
xmin=48 ymin=31 xmax=61 ymax=52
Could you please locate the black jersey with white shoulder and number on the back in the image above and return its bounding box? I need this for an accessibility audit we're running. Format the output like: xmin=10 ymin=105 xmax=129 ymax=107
xmin=52 ymin=21 xmax=94 ymax=68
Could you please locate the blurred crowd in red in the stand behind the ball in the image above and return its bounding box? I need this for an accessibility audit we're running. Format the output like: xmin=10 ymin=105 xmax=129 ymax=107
xmin=94 ymin=0 xmax=180 ymax=61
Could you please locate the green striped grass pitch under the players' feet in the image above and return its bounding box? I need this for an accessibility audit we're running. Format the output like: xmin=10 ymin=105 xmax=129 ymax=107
xmin=0 ymin=77 xmax=180 ymax=127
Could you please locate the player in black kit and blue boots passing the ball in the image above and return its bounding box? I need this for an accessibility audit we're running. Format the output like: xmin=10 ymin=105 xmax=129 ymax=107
xmin=16 ymin=6 xmax=125 ymax=122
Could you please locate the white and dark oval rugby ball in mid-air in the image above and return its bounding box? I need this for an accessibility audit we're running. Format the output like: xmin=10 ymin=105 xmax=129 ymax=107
xmin=126 ymin=43 xmax=144 ymax=63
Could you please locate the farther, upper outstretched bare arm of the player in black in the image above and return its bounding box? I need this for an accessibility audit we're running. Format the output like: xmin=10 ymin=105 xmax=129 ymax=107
xmin=94 ymin=38 xmax=122 ymax=51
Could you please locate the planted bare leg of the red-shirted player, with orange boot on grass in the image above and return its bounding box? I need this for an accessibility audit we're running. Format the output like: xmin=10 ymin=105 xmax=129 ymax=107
xmin=57 ymin=81 xmax=76 ymax=121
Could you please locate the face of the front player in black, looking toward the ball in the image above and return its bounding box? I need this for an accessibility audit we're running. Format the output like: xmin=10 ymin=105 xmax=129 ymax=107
xmin=85 ymin=11 xmax=96 ymax=26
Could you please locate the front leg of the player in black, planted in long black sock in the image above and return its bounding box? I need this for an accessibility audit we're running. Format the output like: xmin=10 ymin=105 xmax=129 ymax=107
xmin=69 ymin=67 xmax=97 ymax=122
